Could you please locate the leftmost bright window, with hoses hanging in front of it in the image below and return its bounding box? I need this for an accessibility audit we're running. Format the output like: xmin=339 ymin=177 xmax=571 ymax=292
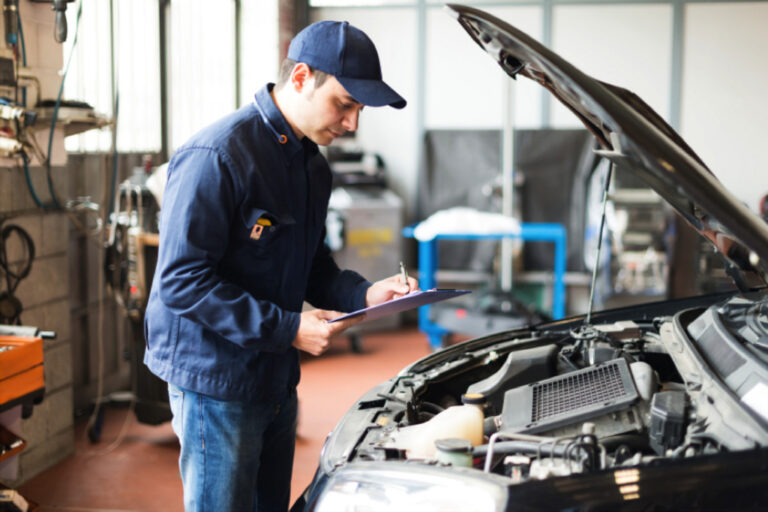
xmin=62 ymin=0 xmax=161 ymax=152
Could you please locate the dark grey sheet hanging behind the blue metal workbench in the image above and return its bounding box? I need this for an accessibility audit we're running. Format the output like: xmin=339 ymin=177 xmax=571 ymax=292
xmin=418 ymin=129 xmax=597 ymax=272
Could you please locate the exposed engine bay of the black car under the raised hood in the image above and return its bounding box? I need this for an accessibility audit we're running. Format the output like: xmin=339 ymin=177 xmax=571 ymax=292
xmin=337 ymin=295 xmax=768 ymax=484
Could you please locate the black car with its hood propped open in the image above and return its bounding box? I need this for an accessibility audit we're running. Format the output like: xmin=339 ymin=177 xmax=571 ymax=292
xmin=293 ymin=5 xmax=768 ymax=512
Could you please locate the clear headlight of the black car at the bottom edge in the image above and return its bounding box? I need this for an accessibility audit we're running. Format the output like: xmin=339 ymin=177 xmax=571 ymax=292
xmin=315 ymin=462 xmax=507 ymax=512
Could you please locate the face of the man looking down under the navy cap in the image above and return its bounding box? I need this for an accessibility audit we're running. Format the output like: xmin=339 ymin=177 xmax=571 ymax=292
xmin=296 ymin=76 xmax=363 ymax=146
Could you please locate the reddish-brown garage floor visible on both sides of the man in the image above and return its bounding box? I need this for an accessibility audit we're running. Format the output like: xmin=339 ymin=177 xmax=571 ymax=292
xmin=18 ymin=328 xmax=430 ymax=512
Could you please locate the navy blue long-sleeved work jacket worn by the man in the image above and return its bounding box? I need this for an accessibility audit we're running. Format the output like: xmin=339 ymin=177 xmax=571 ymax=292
xmin=144 ymin=84 xmax=371 ymax=402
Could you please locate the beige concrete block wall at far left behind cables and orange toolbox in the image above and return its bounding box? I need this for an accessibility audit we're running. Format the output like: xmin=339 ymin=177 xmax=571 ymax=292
xmin=0 ymin=0 xmax=94 ymax=486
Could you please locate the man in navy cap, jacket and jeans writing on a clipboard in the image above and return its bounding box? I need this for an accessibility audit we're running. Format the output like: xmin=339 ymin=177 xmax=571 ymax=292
xmin=145 ymin=22 xmax=417 ymax=511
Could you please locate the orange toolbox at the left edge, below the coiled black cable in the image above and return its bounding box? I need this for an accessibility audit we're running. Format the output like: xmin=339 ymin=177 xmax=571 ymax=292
xmin=0 ymin=335 xmax=45 ymax=411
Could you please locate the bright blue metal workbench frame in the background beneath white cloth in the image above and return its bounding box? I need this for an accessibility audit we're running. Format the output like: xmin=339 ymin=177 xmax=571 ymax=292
xmin=402 ymin=222 xmax=567 ymax=350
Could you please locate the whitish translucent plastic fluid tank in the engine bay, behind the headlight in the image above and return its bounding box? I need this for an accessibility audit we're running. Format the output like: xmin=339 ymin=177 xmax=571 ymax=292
xmin=387 ymin=393 xmax=485 ymax=459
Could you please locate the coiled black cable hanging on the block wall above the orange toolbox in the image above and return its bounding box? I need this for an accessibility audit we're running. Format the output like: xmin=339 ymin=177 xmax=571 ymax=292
xmin=0 ymin=222 xmax=35 ymax=325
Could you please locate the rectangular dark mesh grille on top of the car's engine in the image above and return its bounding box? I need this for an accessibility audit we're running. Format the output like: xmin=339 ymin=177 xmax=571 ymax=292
xmin=531 ymin=363 xmax=626 ymax=421
